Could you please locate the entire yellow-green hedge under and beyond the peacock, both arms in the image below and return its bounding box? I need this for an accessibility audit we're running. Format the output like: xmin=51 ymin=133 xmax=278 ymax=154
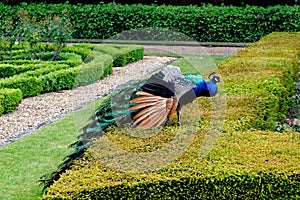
xmin=43 ymin=33 xmax=300 ymax=199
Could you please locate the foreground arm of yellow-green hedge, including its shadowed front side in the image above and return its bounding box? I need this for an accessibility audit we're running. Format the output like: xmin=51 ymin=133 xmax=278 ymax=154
xmin=43 ymin=130 xmax=300 ymax=199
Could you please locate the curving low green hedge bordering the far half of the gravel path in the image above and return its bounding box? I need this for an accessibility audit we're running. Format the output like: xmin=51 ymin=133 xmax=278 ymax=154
xmin=41 ymin=44 xmax=144 ymax=92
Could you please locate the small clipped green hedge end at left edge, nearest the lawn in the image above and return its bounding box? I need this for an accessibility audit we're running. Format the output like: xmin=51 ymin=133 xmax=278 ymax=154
xmin=0 ymin=89 xmax=23 ymax=115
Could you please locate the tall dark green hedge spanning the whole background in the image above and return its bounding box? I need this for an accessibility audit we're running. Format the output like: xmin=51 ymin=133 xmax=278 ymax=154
xmin=0 ymin=3 xmax=300 ymax=42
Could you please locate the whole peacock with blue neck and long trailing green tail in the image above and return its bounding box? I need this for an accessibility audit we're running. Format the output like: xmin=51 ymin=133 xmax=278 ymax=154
xmin=40 ymin=65 xmax=221 ymax=188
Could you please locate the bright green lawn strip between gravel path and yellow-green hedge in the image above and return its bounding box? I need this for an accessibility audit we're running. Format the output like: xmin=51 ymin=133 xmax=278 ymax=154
xmin=0 ymin=56 xmax=227 ymax=200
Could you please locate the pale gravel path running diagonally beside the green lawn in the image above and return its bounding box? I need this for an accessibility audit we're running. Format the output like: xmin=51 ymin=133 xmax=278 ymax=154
xmin=0 ymin=56 xmax=176 ymax=146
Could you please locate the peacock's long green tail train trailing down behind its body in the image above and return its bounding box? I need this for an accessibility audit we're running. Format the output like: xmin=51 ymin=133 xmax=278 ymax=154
xmin=40 ymin=80 xmax=146 ymax=189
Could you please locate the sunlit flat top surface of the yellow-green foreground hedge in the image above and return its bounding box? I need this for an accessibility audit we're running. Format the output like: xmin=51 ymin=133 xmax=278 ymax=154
xmin=44 ymin=132 xmax=300 ymax=199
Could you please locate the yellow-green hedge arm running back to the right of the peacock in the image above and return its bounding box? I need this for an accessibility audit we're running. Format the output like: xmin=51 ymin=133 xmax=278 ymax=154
xmin=218 ymin=33 xmax=300 ymax=130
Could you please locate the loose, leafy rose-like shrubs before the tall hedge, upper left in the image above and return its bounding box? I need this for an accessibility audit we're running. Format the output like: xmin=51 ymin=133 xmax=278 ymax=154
xmin=0 ymin=6 xmax=73 ymax=61
